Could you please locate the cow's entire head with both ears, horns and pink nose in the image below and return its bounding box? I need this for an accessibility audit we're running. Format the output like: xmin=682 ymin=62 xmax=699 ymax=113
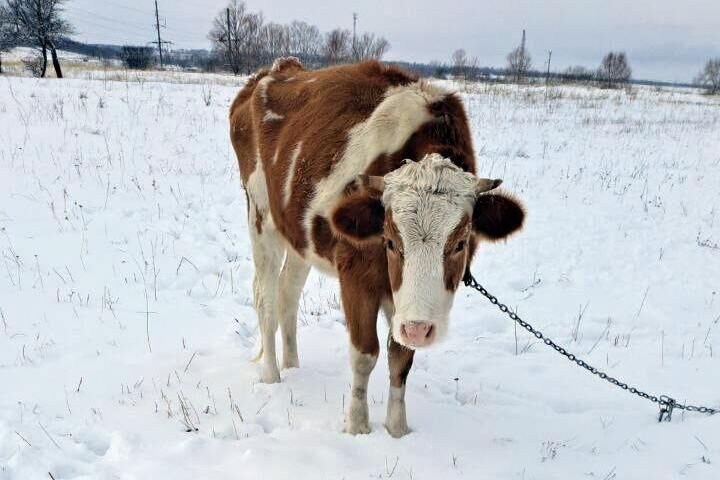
xmin=332 ymin=154 xmax=524 ymax=349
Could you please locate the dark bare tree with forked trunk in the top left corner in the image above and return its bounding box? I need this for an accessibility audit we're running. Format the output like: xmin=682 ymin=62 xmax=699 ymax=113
xmin=6 ymin=0 xmax=73 ymax=78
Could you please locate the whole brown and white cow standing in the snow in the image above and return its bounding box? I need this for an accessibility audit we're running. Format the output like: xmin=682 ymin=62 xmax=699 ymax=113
xmin=230 ymin=58 xmax=524 ymax=437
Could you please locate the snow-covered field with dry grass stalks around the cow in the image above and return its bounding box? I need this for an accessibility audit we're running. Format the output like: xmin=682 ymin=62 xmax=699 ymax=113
xmin=0 ymin=78 xmax=720 ymax=480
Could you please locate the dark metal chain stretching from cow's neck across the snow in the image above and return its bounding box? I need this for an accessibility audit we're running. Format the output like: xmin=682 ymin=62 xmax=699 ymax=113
xmin=463 ymin=272 xmax=720 ymax=422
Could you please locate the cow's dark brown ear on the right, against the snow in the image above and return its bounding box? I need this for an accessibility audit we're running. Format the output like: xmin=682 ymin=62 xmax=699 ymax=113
xmin=473 ymin=193 xmax=525 ymax=241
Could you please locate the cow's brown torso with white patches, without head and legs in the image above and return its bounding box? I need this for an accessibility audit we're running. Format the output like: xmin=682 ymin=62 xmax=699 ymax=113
xmin=230 ymin=59 xmax=474 ymax=269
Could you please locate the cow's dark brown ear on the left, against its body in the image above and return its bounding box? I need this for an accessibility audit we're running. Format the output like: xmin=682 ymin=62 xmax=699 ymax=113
xmin=331 ymin=192 xmax=385 ymax=244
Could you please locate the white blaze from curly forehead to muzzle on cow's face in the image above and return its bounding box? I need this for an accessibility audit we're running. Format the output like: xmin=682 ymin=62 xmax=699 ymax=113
xmin=383 ymin=154 xmax=477 ymax=348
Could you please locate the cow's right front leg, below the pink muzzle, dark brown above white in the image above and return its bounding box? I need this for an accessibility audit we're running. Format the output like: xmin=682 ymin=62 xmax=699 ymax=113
xmin=385 ymin=330 xmax=415 ymax=438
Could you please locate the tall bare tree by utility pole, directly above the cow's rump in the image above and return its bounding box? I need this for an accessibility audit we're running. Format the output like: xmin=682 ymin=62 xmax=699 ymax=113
xmin=208 ymin=0 xmax=263 ymax=75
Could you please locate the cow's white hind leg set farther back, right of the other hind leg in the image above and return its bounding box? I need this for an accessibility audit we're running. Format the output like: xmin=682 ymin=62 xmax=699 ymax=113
xmin=278 ymin=248 xmax=310 ymax=368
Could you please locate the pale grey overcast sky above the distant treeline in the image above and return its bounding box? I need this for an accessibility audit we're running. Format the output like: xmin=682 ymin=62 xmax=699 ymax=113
xmin=66 ymin=0 xmax=720 ymax=81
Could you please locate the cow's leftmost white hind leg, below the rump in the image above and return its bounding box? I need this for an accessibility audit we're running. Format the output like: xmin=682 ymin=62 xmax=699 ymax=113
xmin=248 ymin=204 xmax=285 ymax=383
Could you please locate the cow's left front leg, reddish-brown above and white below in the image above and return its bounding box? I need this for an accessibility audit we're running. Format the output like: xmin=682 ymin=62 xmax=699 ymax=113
xmin=341 ymin=281 xmax=380 ymax=435
